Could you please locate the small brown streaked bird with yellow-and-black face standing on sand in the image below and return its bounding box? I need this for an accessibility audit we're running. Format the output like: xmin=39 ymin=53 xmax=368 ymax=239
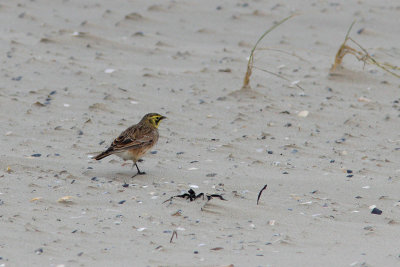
xmin=94 ymin=113 xmax=167 ymax=178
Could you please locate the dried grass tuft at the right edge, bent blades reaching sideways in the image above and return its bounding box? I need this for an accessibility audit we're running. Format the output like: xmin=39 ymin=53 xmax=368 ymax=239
xmin=331 ymin=21 xmax=400 ymax=78
